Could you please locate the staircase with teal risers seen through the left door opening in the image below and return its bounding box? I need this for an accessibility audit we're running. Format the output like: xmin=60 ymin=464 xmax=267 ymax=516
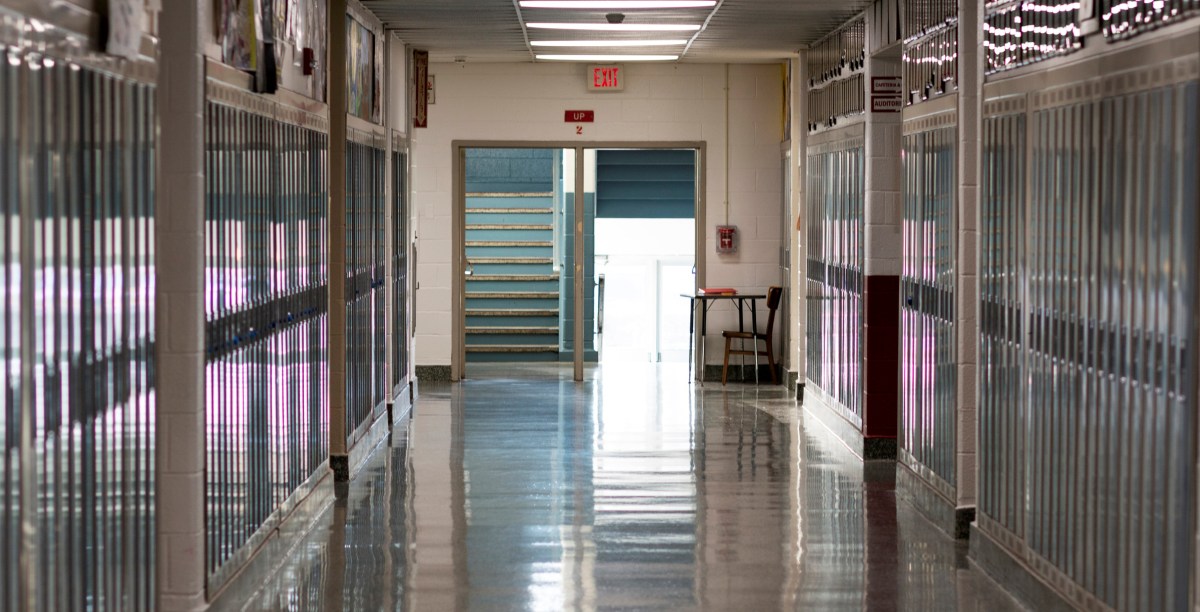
xmin=466 ymin=192 xmax=559 ymax=362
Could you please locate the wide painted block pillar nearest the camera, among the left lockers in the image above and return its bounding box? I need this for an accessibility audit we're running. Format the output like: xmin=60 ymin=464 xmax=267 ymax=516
xmin=155 ymin=0 xmax=209 ymax=610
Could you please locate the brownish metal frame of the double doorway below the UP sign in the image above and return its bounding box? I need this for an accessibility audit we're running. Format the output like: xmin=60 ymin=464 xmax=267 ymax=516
xmin=450 ymin=140 xmax=708 ymax=382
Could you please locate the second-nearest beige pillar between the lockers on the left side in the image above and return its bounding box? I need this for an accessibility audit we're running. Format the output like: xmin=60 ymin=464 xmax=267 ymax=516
xmin=325 ymin=0 xmax=350 ymax=481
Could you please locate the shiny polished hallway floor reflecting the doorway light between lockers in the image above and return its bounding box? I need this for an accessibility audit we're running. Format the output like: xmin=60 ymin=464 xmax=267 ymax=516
xmin=216 ymin=364 xmax=1018 ymax=612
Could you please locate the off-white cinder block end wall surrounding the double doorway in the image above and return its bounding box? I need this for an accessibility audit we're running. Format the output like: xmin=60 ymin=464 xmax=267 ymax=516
xmin=410 ymin=62 xmax=785 ymax=366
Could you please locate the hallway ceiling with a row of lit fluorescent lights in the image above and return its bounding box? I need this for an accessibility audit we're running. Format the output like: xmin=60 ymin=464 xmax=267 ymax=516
xmin=361 ymin=0 xmax=869 ymax=62
